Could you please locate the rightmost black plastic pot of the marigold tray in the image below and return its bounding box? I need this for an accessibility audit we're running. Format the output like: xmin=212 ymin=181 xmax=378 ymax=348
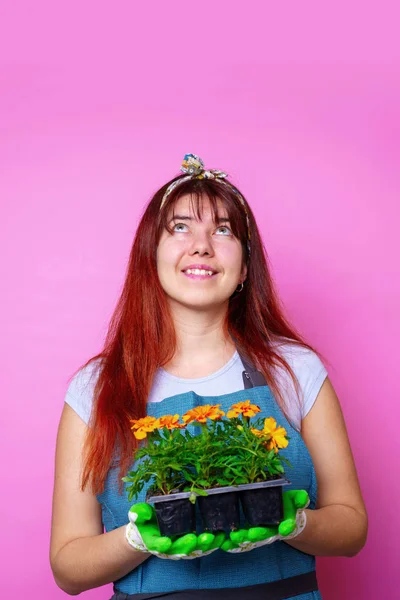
xmin=239 ymin=478 xmax=289 ymax=527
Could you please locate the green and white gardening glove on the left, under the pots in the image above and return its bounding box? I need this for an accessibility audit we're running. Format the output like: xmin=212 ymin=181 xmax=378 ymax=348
xmin=125 ymin=502 xmax=225 ymax=560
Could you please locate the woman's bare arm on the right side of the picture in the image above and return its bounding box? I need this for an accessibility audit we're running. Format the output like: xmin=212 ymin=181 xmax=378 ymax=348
xmin=286 ymin=379 xmax=368 ymax=556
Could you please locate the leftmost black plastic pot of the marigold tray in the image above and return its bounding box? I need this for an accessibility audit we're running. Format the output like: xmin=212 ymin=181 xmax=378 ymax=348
xmin=146 ymin=493 xmax=196 ymax=537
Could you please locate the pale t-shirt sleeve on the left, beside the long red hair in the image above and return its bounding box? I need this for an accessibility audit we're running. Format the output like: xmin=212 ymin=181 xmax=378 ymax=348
xmin=64 ymin=361 xmax=99 ymax=424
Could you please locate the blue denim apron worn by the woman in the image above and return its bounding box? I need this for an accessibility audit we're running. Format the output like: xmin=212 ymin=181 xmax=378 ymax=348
xmin=97 ymin=356 xmax=321 ymax=600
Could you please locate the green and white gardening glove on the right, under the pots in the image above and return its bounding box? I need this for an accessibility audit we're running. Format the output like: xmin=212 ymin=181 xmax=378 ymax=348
xmin=221 ymin=490 xmax=310 ymax=553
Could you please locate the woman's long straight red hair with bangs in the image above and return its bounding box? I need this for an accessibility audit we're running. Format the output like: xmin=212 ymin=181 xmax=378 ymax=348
xmin=82 ymin=177 xmax=322 ymax=493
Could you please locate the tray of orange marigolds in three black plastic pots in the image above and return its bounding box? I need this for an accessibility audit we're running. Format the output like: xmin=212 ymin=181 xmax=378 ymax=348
xmin=123 ymin=400 xmax=289 ymax=536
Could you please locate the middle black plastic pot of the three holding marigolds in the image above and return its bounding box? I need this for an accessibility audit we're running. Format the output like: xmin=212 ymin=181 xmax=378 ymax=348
xmin=197 ymin=488 xmax=240 ymax=533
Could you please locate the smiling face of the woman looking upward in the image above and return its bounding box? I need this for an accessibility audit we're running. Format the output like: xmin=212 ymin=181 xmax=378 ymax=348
xmin=157 ymin=195 xmax=247 ymax=310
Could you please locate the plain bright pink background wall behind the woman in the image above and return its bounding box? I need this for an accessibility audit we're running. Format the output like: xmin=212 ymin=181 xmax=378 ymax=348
xmin=0 ymin=0 xmax=400 ymax=600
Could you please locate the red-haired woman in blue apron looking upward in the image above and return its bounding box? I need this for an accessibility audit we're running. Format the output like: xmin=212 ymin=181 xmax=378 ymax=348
xmin=50 ymin=155 xmax=367 ymax=600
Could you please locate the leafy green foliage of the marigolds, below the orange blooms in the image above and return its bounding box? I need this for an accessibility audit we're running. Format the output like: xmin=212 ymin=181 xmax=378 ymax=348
xmin=123 ymin=415 xmax=291 ymax=501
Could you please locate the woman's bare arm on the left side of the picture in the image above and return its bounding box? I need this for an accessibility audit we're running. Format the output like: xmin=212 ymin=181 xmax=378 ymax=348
xmin=50 ymin=404 xmax=150 ymax=595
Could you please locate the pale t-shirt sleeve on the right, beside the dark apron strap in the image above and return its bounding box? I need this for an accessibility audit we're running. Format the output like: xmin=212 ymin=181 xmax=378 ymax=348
xmin=279 ymin=344 xmax=328 ymax=430
